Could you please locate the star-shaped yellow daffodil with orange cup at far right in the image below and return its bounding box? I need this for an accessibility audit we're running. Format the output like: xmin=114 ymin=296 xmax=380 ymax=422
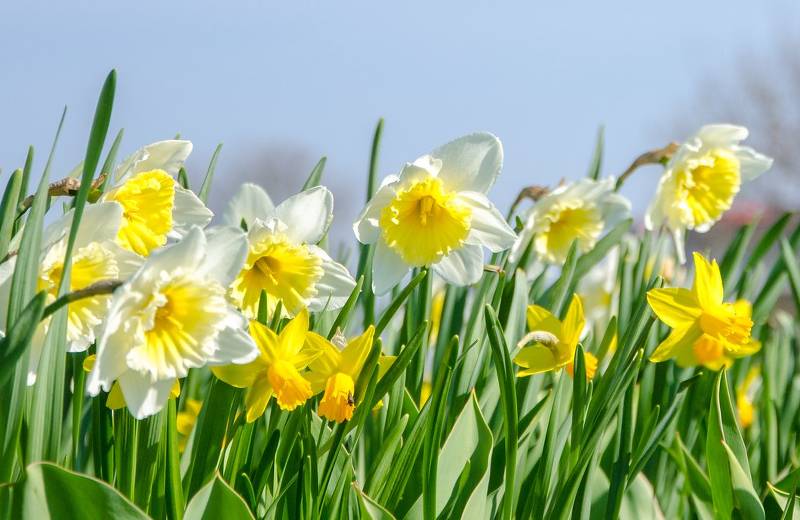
xmin=647 ymin=253 xmax=761 ymax=370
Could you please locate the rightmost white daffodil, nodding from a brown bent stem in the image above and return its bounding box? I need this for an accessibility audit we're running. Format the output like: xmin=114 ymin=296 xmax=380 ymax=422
xmin=645 ymin=125 xmax=772 ymax=263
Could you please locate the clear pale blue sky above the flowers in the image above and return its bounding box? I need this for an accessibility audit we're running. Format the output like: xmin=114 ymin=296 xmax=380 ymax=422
xmin=0 ymin=0 xmax=800 ymax=240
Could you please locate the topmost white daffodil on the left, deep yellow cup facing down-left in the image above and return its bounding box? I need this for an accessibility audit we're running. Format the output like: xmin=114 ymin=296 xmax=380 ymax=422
xmin=101 ymin=140 xmax=214 ymax=256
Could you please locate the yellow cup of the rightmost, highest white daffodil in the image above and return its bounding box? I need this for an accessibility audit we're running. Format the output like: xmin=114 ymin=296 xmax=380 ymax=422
xmin=676 ymin=150 xmax=741 ymax=231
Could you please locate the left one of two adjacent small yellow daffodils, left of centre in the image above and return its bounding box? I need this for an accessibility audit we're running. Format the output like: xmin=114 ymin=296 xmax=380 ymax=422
xmin=211 ymin=309 xmax=320 ymax=422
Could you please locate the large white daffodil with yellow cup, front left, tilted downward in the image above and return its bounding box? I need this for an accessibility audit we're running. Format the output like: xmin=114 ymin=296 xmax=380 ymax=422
xmin=87 ymin=226 xmax=258 ymax=419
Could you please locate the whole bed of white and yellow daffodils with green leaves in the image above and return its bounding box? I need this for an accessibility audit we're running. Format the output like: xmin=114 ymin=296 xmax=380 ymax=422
xmin=0 ymin=71 xmax=800 ymax=520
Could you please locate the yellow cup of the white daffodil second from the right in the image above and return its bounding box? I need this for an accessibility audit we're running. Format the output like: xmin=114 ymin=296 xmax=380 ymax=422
xmin=534 ymin=202 xmax=603 ymax=263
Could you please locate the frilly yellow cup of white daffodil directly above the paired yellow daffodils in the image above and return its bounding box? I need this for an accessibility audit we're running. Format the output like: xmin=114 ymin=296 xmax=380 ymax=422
xmin=232 ymin=235 xmax=323 ymax=318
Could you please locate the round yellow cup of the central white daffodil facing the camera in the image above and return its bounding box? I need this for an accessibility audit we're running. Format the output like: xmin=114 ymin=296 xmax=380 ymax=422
xmin=380 ymin=177 xmax=472 ymax=267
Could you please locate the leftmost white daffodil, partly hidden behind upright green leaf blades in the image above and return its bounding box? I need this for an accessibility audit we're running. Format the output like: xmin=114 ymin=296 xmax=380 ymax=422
xmin=0 ymin=202 xmax=142 ymax=384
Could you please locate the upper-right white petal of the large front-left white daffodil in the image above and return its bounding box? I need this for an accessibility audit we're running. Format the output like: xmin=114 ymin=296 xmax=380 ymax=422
xmin=199 ymin=226 xmax=247 ymax=287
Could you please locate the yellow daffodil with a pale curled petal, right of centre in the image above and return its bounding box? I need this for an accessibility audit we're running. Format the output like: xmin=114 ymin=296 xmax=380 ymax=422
xmin=514 ymin=294 xmax=584 ymax=377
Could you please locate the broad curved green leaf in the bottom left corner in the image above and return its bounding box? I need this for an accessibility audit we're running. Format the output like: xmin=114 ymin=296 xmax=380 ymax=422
xmin=14 ymin=462 xmax=148 ymax=520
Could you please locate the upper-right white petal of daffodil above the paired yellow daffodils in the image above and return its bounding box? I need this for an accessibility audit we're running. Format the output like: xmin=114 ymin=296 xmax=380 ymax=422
xmin=275 ymin=186 xmax=333 ymax=244
